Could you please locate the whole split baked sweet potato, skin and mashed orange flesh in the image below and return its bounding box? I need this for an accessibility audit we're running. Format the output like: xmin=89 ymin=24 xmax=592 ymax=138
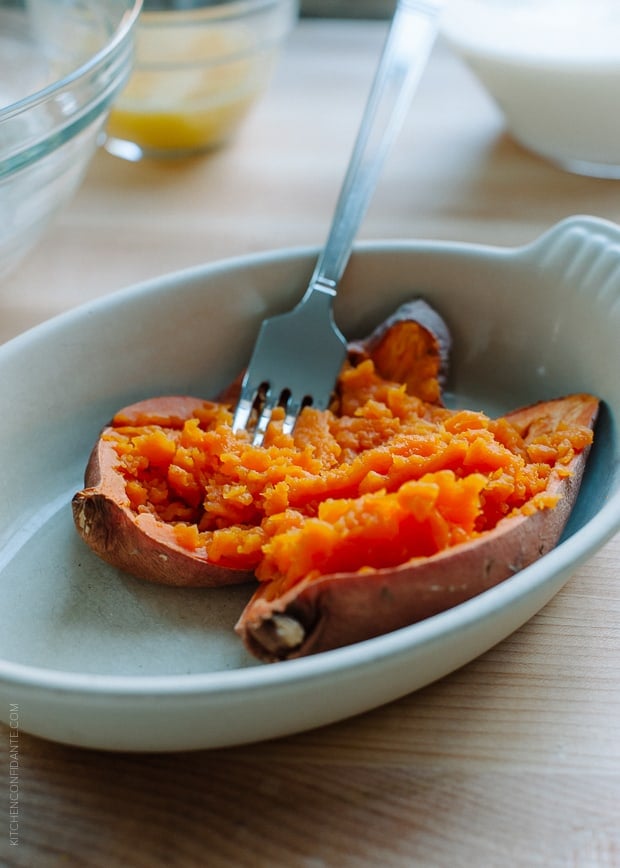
xmin=72 ymin=301 xmax=598 ymax=661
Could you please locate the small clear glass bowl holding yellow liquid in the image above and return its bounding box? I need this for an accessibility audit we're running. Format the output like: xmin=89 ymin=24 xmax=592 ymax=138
xmin=106 ymin=0 xmax=298 ymax=160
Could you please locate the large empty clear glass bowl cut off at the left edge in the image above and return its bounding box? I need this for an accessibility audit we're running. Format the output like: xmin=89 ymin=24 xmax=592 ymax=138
xmin=0 ymin=0 xmax=142 ymax=275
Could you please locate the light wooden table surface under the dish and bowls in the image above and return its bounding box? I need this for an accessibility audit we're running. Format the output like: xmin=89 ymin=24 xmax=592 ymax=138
xmin=0 ymin=20 xmax=620 ymax=868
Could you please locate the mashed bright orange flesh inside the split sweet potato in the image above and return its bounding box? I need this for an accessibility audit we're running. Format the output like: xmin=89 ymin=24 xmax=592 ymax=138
xmin=105 ymin=359 xmax=592 ymax=596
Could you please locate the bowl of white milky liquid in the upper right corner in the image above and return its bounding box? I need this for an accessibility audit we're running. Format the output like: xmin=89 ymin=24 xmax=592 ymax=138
xmin=444 ymin=0 xmax=620 ymax=178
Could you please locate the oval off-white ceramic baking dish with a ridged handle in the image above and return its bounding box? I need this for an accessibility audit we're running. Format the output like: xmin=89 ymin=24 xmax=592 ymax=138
xmin=0 ymin=217 xmax=620 ymax=750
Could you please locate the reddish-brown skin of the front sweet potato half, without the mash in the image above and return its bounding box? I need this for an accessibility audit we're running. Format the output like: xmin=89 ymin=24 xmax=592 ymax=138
xmin=235 ymin=395 xmax=598 ymax=662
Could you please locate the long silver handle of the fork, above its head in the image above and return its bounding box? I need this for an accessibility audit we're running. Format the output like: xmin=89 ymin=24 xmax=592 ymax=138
xmin=309 ymin=0 xmax=443 ymax=295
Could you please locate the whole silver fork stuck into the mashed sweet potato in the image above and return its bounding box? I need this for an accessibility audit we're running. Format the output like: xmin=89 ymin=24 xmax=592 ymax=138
xmin=233 ymin=0 xmax=443 ymax=445
